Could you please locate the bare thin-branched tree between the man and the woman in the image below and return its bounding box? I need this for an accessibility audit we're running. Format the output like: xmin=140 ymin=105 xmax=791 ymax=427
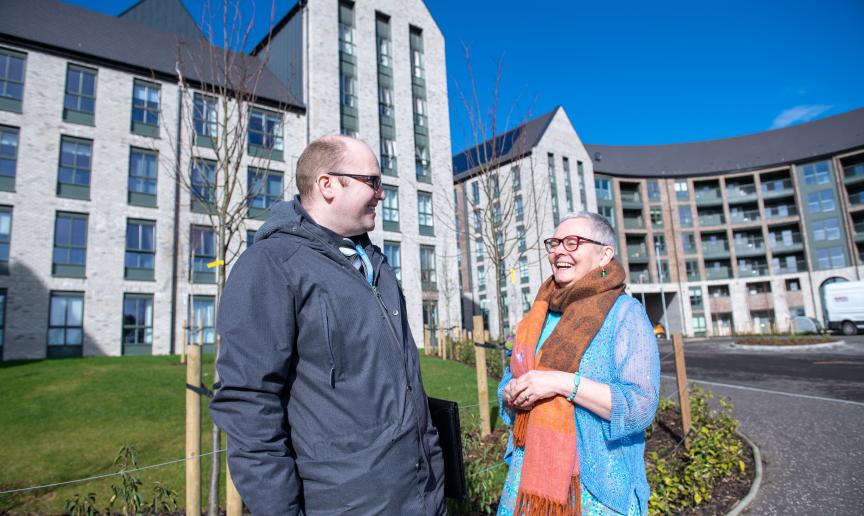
xmin=448 ymin=48 xmax=547 ymax=338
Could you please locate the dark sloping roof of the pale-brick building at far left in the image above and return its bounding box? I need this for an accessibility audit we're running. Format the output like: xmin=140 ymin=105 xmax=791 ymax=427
xmin=0 ymin=0 xmax=305 ymax=111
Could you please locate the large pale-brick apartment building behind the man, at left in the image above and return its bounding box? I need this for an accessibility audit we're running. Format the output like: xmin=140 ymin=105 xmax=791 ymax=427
xmin=0 ymin=0 xmax=458 ymax=360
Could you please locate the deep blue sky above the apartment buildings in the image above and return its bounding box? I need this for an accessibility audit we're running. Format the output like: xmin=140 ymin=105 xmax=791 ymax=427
xmin=71 ymin=0 xmax=864 ymax=150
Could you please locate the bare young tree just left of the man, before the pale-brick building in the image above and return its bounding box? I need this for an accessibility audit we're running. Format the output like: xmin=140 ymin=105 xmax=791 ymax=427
xmin=154 ymin=0 xmax=292 ymax=516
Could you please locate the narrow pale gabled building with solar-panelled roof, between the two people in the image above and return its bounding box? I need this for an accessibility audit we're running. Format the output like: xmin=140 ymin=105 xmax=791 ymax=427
xmin=453 ymin=107 xmax=597 ymax=337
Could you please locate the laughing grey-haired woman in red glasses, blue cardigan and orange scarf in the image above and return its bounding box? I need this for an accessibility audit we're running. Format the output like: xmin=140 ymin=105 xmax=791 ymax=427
xmin=498 ymin=212 xmax=660 ymax=515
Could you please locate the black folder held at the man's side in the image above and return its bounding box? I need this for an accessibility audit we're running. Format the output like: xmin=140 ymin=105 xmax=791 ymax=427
xmin=429 ymin=398 xmax=468 ymax=501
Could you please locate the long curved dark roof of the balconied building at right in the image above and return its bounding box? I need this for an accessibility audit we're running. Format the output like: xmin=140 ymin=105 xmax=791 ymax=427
xmin=585 ymin=108 xmax=864 ymax=177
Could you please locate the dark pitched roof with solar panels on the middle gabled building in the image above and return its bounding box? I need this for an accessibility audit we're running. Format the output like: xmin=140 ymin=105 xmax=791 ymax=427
xmin=453 ymin=106 xmax=561 ymax=182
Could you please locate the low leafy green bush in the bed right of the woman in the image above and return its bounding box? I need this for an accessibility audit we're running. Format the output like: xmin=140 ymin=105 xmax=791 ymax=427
xmin=646 ymin=386 xmax=746 ymax=514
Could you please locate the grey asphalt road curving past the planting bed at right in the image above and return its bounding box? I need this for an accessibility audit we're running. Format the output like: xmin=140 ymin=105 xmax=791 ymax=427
xmin=660 ymin=336 xmax=864 ymax=516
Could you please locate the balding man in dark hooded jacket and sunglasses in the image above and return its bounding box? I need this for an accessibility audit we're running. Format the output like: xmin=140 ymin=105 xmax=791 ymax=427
xmin=210 ymin=136 xmax=445 ymax=516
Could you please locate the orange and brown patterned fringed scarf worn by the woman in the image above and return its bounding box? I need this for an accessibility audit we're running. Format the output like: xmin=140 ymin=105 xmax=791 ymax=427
xmin=510 ymin=260 xmax=625 ymax=516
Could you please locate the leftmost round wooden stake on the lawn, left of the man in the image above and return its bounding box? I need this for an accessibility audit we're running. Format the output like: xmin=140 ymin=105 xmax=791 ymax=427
xmin=183 ymin=329 xmax=203 ymax=514
